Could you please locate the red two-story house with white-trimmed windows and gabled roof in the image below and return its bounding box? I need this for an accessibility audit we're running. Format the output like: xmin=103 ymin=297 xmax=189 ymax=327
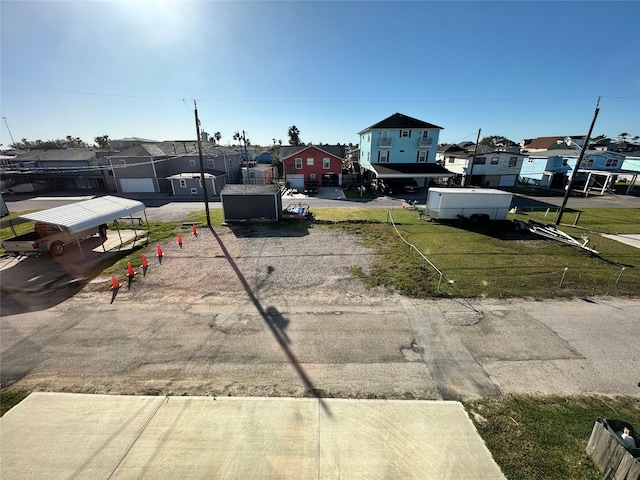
xmin=280 ymin=145 xmax=345 ymax=189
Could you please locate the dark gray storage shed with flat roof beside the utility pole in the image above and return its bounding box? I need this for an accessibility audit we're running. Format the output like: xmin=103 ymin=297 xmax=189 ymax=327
xmin=220 ymin=184 xmax=282 ymax=222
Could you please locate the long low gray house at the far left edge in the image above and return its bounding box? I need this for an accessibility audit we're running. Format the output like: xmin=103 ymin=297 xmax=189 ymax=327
xmin=2 ymin=148 xmax=115 ymax=192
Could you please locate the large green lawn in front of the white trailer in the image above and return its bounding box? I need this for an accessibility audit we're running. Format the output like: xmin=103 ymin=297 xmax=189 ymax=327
xmin=314 ymin=208 xmax=640 ymax=298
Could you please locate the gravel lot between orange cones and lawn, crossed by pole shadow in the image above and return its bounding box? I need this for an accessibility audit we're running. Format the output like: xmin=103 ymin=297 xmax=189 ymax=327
xmin=84 ymin=224 xmax=392 ymax=304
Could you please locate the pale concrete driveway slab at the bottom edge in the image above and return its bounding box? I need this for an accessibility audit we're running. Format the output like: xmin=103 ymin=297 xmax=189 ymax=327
xmin=0 ymin=393 xmax=505 ymax=480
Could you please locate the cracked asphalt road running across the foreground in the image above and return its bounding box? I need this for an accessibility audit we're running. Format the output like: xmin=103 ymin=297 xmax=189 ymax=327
xmin=0 ymin=292 xmax=640 ymax=400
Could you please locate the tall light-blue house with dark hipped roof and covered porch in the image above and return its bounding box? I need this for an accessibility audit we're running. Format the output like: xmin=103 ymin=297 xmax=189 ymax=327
xmin=358 ymin=113 xmax=453 ymax=187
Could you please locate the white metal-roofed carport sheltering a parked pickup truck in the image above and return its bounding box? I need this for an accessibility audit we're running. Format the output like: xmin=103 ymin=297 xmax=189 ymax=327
xmin=18 ymin=195 xmax=149 ymax=260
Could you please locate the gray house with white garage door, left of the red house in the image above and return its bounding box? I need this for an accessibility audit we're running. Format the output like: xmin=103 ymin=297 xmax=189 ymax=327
xmin=109 ymin=140 xmax=242 ymax=195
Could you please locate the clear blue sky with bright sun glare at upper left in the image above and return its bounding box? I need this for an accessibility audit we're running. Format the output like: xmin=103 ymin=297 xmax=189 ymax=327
xmin=0 ymin=0 xmax=640 ymax=145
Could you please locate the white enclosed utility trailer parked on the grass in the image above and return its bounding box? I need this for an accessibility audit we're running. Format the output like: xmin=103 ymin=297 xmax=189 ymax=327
xmin=425 ymin=187 xmax=512 ymax=222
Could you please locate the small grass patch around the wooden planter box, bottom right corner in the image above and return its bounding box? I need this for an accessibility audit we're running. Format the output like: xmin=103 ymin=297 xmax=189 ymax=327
xmin=465 ymin=396 xmax=640 ymax=480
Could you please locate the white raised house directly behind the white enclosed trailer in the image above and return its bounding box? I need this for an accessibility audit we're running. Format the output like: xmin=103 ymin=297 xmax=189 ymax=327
xmin=436 ymin=145 xmax=526 ymax=187
